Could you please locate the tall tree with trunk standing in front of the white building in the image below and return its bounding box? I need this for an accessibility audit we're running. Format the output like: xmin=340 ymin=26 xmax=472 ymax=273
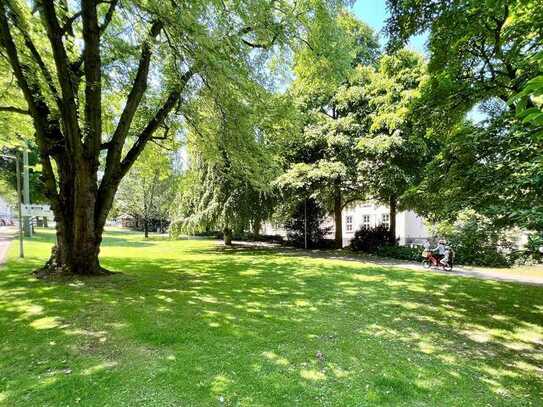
xmin=354 ymin=49 xmax=428 ymax=236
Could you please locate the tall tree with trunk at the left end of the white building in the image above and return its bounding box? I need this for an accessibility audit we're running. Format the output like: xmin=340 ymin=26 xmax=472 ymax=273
xmin=278 ymin=12 xmax=379 ymax=247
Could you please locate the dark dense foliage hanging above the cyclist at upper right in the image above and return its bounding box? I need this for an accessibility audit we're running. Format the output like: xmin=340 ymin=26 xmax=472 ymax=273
xmin=388 ymin=0 xmax=543 ymax=230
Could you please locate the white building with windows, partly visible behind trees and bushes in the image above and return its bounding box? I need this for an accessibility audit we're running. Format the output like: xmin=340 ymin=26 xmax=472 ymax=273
xmin=343 ymin=202 xmax=432 ymax=246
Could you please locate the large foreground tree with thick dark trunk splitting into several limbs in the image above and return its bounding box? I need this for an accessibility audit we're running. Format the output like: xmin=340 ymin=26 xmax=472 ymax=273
xmin=0 ymin=0 xmax=339 ymax=274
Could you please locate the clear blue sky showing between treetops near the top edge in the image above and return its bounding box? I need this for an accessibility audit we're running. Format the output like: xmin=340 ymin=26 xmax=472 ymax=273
xmin=352 ymin=0 xmax=427 ymax=55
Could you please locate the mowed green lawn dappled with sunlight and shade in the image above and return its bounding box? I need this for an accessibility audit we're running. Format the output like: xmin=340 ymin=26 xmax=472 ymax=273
xmin=0 ymin=231 xmax=543 ymax=407
